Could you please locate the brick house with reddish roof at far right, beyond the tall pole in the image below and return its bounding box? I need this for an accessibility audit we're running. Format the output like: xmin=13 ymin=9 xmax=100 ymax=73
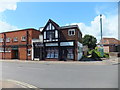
xmin=99 ymin=38 xmax=120 ymax=52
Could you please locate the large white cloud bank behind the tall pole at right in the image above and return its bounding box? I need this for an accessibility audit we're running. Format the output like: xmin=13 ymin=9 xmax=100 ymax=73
xmin=67 ymin=15 xmax=118 ymax=42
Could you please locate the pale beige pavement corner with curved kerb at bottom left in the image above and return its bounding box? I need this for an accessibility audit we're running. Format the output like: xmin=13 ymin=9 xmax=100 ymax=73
xmin=0 ymin=79 xmax=37 ymax=90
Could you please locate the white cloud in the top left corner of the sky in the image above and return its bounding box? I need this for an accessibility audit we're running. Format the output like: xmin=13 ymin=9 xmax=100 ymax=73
xmin=0 ymin=0 xmax=20 ymax=12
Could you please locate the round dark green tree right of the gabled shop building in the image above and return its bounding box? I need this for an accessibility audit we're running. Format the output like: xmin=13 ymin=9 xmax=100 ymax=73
xmin=82 ymin=35 xmax=97 ymax=49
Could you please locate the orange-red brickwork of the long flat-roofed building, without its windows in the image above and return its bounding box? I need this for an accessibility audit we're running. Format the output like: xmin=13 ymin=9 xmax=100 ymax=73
xmin=0 ymin=29 xmax=40 ymax=60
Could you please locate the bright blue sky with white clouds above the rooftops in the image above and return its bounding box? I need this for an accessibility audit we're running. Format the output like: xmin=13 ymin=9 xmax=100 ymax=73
xmin=0 ymin=0 xmax=118 ymax=41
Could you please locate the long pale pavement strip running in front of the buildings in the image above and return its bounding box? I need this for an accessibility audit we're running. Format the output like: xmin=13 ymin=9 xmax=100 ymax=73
xmin=0 ymin=57 xmax=120 ymax=65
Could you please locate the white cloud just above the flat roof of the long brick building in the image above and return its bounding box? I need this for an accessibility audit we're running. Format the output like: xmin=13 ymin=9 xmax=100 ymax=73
xmin=0 ymin=21 xmax=18 ymax=33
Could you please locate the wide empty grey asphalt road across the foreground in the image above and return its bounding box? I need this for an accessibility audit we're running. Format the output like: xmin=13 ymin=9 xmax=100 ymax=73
xmin=2 ymin=62 xmax=118 ymax=88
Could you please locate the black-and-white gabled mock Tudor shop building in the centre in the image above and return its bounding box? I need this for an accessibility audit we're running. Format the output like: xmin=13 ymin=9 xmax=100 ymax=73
xmin=32 ymin=19 xmax=82 ymax=61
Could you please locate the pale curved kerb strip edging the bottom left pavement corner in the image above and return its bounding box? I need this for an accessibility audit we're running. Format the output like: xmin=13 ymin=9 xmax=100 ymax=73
xmin=6 ymin=79 xmax=38 ymax=88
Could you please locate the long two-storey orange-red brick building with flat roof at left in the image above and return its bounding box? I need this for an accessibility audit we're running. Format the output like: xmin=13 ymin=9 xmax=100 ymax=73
xmin=0 ymin=28 xmax=40 ymax=60
